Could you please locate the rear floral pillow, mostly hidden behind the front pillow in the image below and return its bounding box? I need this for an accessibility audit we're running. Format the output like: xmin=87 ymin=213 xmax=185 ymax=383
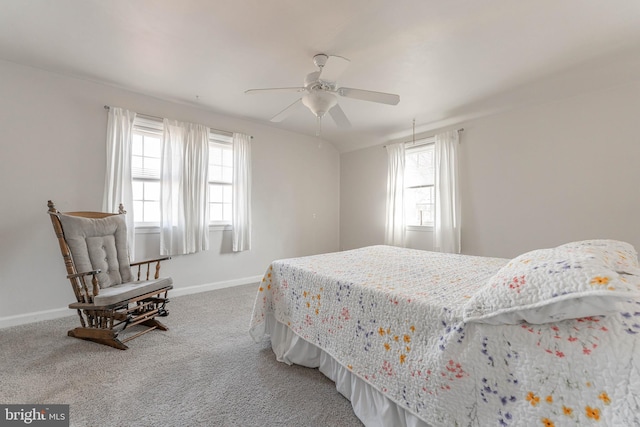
xmin=558 ymin=239 xmax=640 ymax=275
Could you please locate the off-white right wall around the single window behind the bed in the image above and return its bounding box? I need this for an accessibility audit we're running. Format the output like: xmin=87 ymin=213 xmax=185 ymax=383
xmin=340 ymin=83 xmax=640 ymax=257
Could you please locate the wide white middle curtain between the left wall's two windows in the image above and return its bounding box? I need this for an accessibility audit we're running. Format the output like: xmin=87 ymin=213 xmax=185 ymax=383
xmin=160 ymin=119 xmax=209 ymax=255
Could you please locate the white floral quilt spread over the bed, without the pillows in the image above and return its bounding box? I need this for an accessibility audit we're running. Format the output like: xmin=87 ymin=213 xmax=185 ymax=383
xmin=250 ymin=246 xmax=640 ymax=426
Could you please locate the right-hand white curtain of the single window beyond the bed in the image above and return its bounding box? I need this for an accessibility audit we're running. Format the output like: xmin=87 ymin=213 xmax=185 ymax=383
xmin=434 ymin=130 xmax=461 ymax=253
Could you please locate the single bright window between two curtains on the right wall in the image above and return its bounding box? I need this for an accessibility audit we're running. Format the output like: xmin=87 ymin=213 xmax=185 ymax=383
xmin=404 ymin=138 xmax=435 ymax=226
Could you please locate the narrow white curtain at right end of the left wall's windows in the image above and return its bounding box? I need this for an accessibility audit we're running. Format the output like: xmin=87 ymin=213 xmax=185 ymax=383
xmin=232 ymin=133 xmax=251 ymax=252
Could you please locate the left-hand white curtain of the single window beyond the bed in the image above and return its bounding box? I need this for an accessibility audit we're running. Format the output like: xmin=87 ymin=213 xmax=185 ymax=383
xmin=384 ymin=142 xmax=406 ymax=247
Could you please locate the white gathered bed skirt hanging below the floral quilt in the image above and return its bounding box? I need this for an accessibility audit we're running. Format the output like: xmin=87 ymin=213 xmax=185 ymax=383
xmin=251 ymin=314 xmax=429 ymax=427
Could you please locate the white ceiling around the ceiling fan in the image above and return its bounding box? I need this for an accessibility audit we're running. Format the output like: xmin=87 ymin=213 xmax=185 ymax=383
xmin=0 ymin=0 xmax=640 ymax=151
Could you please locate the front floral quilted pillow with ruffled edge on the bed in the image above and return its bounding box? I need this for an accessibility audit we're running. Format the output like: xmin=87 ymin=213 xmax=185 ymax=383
xmin=463 ymin=245 xmax=640 ymax=325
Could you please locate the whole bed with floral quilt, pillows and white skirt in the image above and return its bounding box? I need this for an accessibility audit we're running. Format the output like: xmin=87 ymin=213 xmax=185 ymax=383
xmin=249 ymin=240 xmax=640 ymax=426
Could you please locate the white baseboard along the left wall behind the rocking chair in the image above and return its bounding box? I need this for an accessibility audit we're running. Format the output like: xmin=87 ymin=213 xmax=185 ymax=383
xmin=0 ymin=276 xmax=262 ymax=329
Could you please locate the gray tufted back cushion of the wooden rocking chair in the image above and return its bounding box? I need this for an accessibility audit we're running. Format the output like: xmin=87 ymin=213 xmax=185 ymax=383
xmin=60 ymin=214 xmax=133 ymax=289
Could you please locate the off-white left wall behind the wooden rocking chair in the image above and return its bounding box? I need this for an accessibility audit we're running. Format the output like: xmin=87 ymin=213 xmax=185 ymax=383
xmin=0 ymin=61 xmax=340 ymax=327
